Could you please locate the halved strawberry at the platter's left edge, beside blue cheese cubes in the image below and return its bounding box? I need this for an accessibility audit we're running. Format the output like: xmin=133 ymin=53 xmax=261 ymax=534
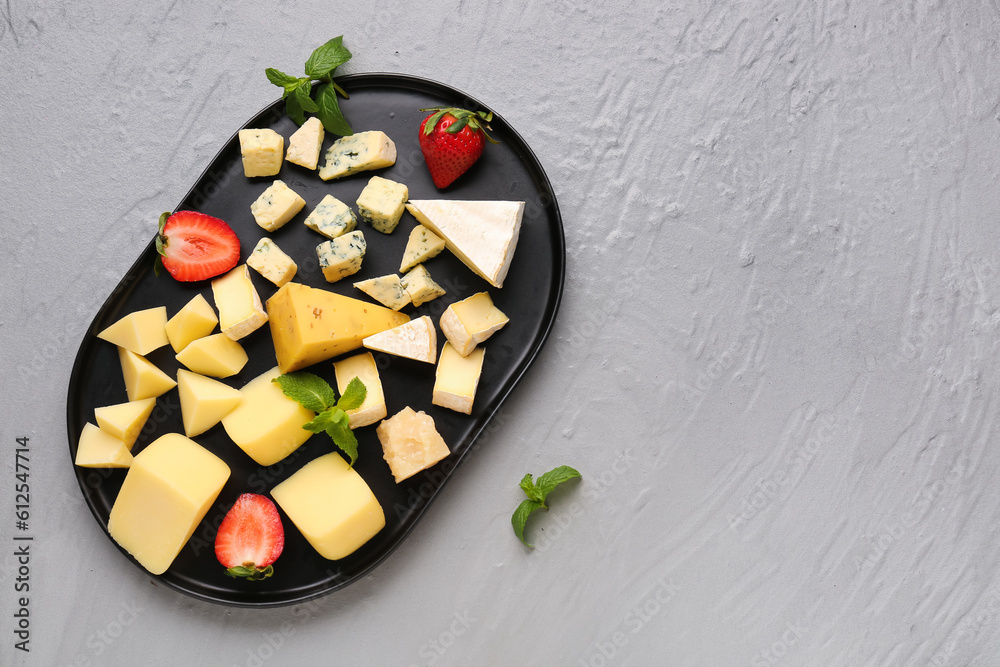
xmin=156 ymin=211 xmax=240 ymax=282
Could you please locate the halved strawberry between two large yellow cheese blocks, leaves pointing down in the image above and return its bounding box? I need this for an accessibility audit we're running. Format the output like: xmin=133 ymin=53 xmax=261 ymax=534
xmin=215 ymin=493 xmax=285 ymax=581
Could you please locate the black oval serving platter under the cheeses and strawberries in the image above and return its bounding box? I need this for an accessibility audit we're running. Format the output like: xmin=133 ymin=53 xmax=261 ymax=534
xmin=67 ymin=73 xmax=566 ymax=607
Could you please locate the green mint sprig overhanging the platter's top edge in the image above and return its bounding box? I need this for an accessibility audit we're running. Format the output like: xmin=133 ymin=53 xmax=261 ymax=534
xmin=264 ymin=35 xmax=354 ymax=137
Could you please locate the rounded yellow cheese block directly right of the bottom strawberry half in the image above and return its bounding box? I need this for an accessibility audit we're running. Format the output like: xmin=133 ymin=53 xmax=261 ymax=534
xmin=271 ymin=453 xmax=385 ymax=560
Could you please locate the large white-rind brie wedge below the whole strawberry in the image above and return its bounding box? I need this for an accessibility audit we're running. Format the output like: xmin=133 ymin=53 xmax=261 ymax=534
xmin=406 ymin=199 xmax=524 ymax=287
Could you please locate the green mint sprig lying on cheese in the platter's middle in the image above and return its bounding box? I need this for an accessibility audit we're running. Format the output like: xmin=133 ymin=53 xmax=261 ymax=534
xmin=271 ymin=371 xmax=368 ymax=466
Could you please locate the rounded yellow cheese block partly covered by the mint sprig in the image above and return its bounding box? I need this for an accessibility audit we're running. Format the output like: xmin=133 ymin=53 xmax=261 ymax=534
xmin=222 ymin=368 xmax=316 ymax=466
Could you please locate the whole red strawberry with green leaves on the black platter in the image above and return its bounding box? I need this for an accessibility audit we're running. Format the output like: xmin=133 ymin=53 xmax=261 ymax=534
xmin=420 ymin=107 xmax=498 ymax=188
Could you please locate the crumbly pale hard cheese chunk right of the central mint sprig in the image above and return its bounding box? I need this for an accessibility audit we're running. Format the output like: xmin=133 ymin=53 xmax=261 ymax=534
xmin=375 ymin=406 xmax=451 ymax=484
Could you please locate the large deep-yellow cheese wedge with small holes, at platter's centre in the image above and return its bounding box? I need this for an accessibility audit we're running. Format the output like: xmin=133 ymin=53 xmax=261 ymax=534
xmin=267 ymin=282 xmax=410 ymax=373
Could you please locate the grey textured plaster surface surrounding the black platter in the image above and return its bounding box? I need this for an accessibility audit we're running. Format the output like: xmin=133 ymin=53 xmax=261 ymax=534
xmin=0 ymin=0 xmax=1000 ymax=667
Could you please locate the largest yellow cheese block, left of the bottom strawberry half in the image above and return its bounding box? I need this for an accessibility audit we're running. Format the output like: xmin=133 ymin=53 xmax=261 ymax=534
xmin=108 ymin=433 xmax=230 ymax=574
